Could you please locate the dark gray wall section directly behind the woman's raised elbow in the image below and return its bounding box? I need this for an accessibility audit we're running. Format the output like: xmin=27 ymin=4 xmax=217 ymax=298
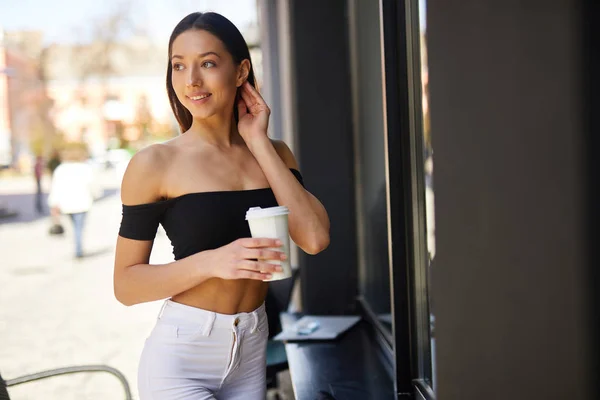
xmin=290 ymin=0 xmax=357 ymax=314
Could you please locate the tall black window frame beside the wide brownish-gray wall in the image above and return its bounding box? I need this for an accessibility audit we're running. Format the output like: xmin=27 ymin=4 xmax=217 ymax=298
xmin=380 ymin=0 xmax=435 ymax=400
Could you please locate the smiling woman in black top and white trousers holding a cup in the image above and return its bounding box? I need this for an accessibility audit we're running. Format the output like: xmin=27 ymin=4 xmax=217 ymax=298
xmin=114 ymin=13 xmax=329 ymax=400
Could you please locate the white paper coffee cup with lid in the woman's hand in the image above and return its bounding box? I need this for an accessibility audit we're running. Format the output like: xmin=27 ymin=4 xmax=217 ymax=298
xmin=246 ymin=206 xmax=292 ymax=282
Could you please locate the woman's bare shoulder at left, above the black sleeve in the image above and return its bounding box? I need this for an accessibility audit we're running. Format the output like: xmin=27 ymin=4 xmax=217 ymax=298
xmin=121 ymin=142 xmax=175 ymax=205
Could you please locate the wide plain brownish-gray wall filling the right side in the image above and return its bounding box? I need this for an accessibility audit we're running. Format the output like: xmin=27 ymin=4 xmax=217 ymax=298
xmin=427 ymin=0 xmax=592 ymax=400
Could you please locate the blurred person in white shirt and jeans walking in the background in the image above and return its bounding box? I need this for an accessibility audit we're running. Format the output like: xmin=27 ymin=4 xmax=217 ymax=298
xmin=48 ymin=148 xmax=95 ymax=258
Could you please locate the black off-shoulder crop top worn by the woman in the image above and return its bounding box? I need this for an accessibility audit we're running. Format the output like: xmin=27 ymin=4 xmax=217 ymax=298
xmin=119 ymin=169 xmax=304 ymax=260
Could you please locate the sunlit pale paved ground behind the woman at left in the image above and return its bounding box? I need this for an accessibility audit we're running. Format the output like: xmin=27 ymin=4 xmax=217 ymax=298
xmin=0 ymin=171 xmax=292 ymax=400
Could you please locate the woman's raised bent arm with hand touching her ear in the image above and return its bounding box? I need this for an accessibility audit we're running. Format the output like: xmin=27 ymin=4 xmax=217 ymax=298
xmin=238 ymin=82 xmax=329 ymax=254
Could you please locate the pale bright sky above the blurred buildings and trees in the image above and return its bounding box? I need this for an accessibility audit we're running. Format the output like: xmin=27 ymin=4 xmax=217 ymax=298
xmin=0 ymin=0 xmax=257 ymax=44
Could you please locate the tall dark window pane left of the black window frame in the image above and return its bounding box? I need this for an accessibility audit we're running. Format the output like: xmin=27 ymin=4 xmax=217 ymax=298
xmin=351 ymin=1 xmax=392 ymax=336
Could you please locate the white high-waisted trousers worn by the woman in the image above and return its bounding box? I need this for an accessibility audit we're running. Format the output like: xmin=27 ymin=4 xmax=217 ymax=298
xmin=138 ymin=300 xmax=269 ymax=400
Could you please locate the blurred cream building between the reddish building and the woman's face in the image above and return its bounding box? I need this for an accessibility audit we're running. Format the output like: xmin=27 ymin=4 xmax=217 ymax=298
xmin=45 ymin=37 xmax=176 ymax=155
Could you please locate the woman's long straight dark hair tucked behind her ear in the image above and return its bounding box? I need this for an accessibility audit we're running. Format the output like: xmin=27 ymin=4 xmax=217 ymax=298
xmin=167 ymin=12 xmax=256 ymax=133
